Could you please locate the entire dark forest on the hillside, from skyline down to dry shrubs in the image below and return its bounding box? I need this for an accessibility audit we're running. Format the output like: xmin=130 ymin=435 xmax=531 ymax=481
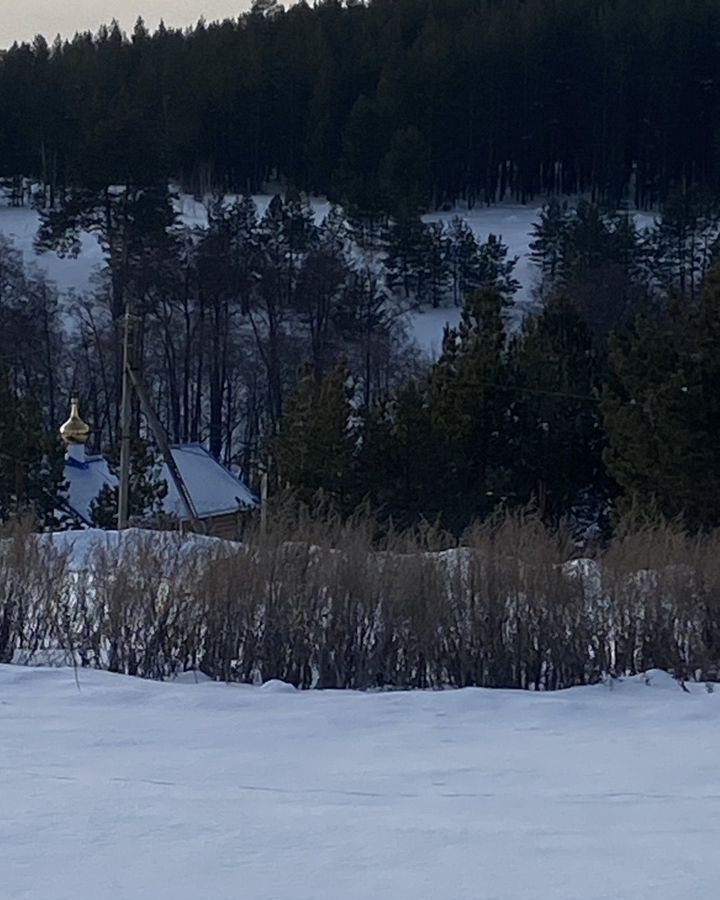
xmin=0 ymin=0 xmax=720 ymax=540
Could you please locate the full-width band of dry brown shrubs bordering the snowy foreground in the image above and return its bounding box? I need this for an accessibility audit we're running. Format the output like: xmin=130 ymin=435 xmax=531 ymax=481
xmin=0 ymin=504 xmax=720 ymax=690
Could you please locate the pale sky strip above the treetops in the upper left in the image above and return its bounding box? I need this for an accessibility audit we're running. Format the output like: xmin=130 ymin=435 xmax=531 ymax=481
xmin=0 ymin=0 xmax=251 ymax=47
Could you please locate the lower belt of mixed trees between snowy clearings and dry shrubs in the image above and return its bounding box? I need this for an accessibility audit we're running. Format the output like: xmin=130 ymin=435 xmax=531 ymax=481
xmin=0 ymin=183 xmax=720 ymax=535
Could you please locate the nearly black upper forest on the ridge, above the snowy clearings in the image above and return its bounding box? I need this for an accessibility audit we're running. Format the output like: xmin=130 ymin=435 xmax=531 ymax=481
xmin=0 ymin=0 xmax=720 ymax=212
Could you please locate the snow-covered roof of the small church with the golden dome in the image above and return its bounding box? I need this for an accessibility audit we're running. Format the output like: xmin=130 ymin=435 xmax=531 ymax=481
xmin=64 ymin=444 xmax=258 ymax=524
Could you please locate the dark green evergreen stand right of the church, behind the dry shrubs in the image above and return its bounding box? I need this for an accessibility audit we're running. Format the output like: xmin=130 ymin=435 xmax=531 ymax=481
xmin=273 ymin=192 xmax=720 ymax=538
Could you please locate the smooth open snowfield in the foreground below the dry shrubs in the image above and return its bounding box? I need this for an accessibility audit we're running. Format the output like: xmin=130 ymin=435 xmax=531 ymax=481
xmin=0 ymin=666 xmax=720 ymax=900
